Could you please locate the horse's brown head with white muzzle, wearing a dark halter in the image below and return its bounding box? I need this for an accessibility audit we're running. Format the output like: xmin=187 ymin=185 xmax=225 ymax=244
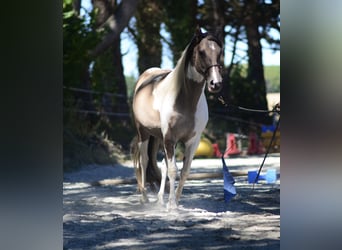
xmin=190 ymin=28 xmax=222 ymax=93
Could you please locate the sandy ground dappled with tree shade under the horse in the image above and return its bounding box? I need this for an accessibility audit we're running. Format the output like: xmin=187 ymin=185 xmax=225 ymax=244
xmin=63 ymin=154 xmax=280 ymax=249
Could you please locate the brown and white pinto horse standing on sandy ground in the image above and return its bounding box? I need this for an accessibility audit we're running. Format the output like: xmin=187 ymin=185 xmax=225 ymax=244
xmin=132 ymin=27 xmax=222 ymax=210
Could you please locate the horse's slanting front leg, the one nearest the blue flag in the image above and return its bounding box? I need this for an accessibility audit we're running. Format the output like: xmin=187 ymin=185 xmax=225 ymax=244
xmin=176 ymin=137 xmax=200 ymax=204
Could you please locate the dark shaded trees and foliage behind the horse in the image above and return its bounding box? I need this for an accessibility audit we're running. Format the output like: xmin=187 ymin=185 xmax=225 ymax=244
xmin=63 ymin=0 xmax=280 ymax=170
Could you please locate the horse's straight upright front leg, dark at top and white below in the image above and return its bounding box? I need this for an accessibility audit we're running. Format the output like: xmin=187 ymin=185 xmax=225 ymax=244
xmin=164 ymin=139 xmax=178 ymax=210
